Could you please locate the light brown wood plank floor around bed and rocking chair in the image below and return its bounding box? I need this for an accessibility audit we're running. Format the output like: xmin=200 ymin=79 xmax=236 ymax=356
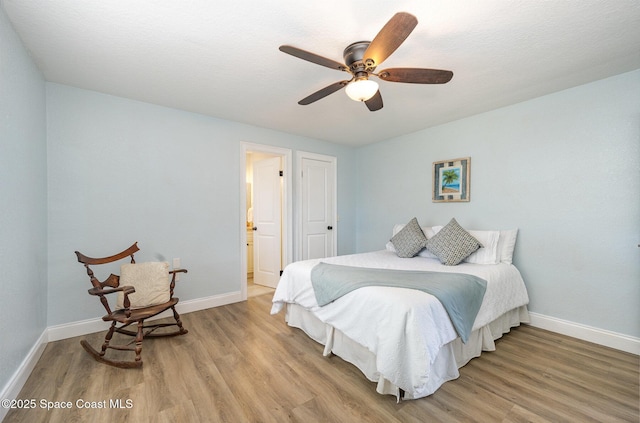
xmin=4 ymin=295 xmax=640 ymax=423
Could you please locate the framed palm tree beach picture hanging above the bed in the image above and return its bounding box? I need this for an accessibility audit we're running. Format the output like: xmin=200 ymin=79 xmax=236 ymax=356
xmin=432 ymin=157 xmax=471 ymax=203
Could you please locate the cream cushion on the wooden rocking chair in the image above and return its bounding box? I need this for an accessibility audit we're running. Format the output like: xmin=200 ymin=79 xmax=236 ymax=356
xmin=116 ymin=262 xmax=171 ymax=309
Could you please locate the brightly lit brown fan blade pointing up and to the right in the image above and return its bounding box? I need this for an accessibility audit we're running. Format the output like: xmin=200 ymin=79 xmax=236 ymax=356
xmin=364 ymin=12 xmax=418 ymax=67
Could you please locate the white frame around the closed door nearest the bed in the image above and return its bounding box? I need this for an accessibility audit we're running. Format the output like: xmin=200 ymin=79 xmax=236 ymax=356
xmin=295 ymin=151 xmax=340 ymax=261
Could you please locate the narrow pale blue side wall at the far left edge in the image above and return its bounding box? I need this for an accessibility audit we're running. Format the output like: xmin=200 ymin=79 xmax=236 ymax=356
xmin=0 ymin=8 xmax=47 ymax=400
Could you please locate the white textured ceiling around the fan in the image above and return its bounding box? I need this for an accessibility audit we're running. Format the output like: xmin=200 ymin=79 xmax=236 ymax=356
xmin=1 ymin=0 xmax=640 ymax=146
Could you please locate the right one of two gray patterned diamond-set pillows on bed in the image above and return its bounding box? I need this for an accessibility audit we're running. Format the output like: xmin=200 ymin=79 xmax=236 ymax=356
xmin=426 ymin=219 xmax=482 ymax=266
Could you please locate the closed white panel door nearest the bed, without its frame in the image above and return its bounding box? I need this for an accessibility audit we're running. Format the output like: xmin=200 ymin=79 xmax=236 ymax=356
xmin=302 ymin=157 xmax=335 ymax=260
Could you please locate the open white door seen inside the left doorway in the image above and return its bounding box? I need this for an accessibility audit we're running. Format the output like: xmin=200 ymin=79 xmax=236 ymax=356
xmin=253 ymin=157 xmax=282 ymax=288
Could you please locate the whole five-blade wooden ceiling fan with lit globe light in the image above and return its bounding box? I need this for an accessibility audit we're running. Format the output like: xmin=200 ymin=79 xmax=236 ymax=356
xmin=280 ymin=12 xmax=453 ymax=112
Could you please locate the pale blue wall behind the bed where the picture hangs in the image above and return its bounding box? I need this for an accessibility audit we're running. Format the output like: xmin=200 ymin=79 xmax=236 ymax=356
xmin=357 ymin=71 xmax=640 ymax=337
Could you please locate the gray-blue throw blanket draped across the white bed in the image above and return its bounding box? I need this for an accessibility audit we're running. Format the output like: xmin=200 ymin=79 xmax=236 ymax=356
xmin=311 ymin=263 xmax=487 ymax=343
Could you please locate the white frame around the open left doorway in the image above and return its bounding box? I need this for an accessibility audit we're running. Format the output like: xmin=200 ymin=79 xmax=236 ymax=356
xmin=239 ymin=142 xmax=293 ymax=301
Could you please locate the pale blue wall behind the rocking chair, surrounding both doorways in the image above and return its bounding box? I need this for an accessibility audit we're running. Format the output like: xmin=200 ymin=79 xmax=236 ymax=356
xmin=47 ymin=83 xmax=355 ymax=326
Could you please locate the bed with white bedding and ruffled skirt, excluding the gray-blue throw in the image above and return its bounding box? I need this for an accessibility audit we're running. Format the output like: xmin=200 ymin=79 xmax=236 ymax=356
xmin=271 ymin=219 xmax=529 ymax=400
